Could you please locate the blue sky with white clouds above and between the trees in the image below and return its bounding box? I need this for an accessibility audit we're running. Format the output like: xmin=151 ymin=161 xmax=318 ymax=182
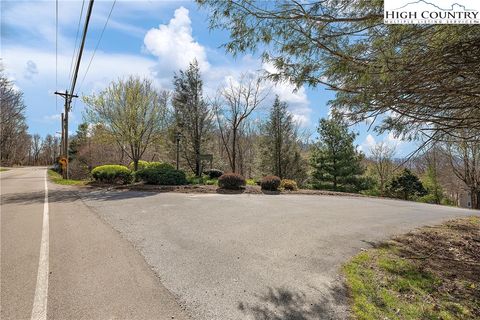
xmin=1 ymin=0 xmax=414 ymax=156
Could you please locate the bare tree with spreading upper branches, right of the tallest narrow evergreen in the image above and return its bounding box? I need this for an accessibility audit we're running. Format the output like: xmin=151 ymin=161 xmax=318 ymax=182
xmin=214 ymin=75 xmax=267 ymax=172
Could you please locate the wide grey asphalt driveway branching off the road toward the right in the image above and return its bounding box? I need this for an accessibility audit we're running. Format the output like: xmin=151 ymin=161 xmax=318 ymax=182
xmin=83 ymin=191 xmax=474 ymax=320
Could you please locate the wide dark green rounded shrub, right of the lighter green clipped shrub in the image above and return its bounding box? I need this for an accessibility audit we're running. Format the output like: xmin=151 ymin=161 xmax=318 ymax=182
xmin=136 ymin=166 xmax=187 ymax=186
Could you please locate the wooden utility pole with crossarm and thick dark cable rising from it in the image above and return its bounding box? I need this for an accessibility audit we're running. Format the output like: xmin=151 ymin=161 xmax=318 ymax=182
xmin=55 ymin=0 xmax=94 ymax=179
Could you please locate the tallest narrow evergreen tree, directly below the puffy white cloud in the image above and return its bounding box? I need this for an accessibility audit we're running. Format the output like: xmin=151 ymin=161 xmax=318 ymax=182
xmin=172 ymin=60 xmax=213 ymax=176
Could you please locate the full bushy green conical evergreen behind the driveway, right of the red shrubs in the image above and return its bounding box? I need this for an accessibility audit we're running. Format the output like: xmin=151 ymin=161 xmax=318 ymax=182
xmin=311 ymin=117 xmax=364 ymax=190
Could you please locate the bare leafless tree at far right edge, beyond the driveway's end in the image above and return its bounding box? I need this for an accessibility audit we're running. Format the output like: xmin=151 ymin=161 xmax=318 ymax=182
xmin=444 ymin=130 xmax=480 ymax=209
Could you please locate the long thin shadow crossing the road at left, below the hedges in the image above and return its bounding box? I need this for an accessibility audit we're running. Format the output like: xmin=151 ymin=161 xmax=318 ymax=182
xmin=1 ymin=190 xmax=155 ymax=205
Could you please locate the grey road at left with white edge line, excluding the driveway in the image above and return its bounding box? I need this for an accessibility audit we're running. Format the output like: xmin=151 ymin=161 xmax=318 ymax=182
xmin=0 ymin=168 xmax=187 ymax=320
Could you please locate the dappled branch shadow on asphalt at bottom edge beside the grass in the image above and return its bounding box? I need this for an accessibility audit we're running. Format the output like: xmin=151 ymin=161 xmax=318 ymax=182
xmin=238 ymin=285 xmax=348 ymax=320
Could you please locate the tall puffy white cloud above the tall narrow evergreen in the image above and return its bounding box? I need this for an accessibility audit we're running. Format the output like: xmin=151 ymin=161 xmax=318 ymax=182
xmin=143 ymin=7 xmax=210 ymax=81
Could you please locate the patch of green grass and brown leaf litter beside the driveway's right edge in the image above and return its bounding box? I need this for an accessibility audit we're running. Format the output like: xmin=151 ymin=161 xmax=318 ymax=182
xmin=343 ymin=217 xmax=480 ymax=320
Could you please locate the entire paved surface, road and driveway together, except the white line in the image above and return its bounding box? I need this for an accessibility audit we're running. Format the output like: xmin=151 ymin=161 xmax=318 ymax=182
xmin=1 ymin=168 xmax=475 ymax=320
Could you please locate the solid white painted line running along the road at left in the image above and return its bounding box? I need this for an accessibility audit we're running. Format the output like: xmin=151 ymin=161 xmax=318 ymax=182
xmin=32 ymin=170 xmax=49 ymax=320
